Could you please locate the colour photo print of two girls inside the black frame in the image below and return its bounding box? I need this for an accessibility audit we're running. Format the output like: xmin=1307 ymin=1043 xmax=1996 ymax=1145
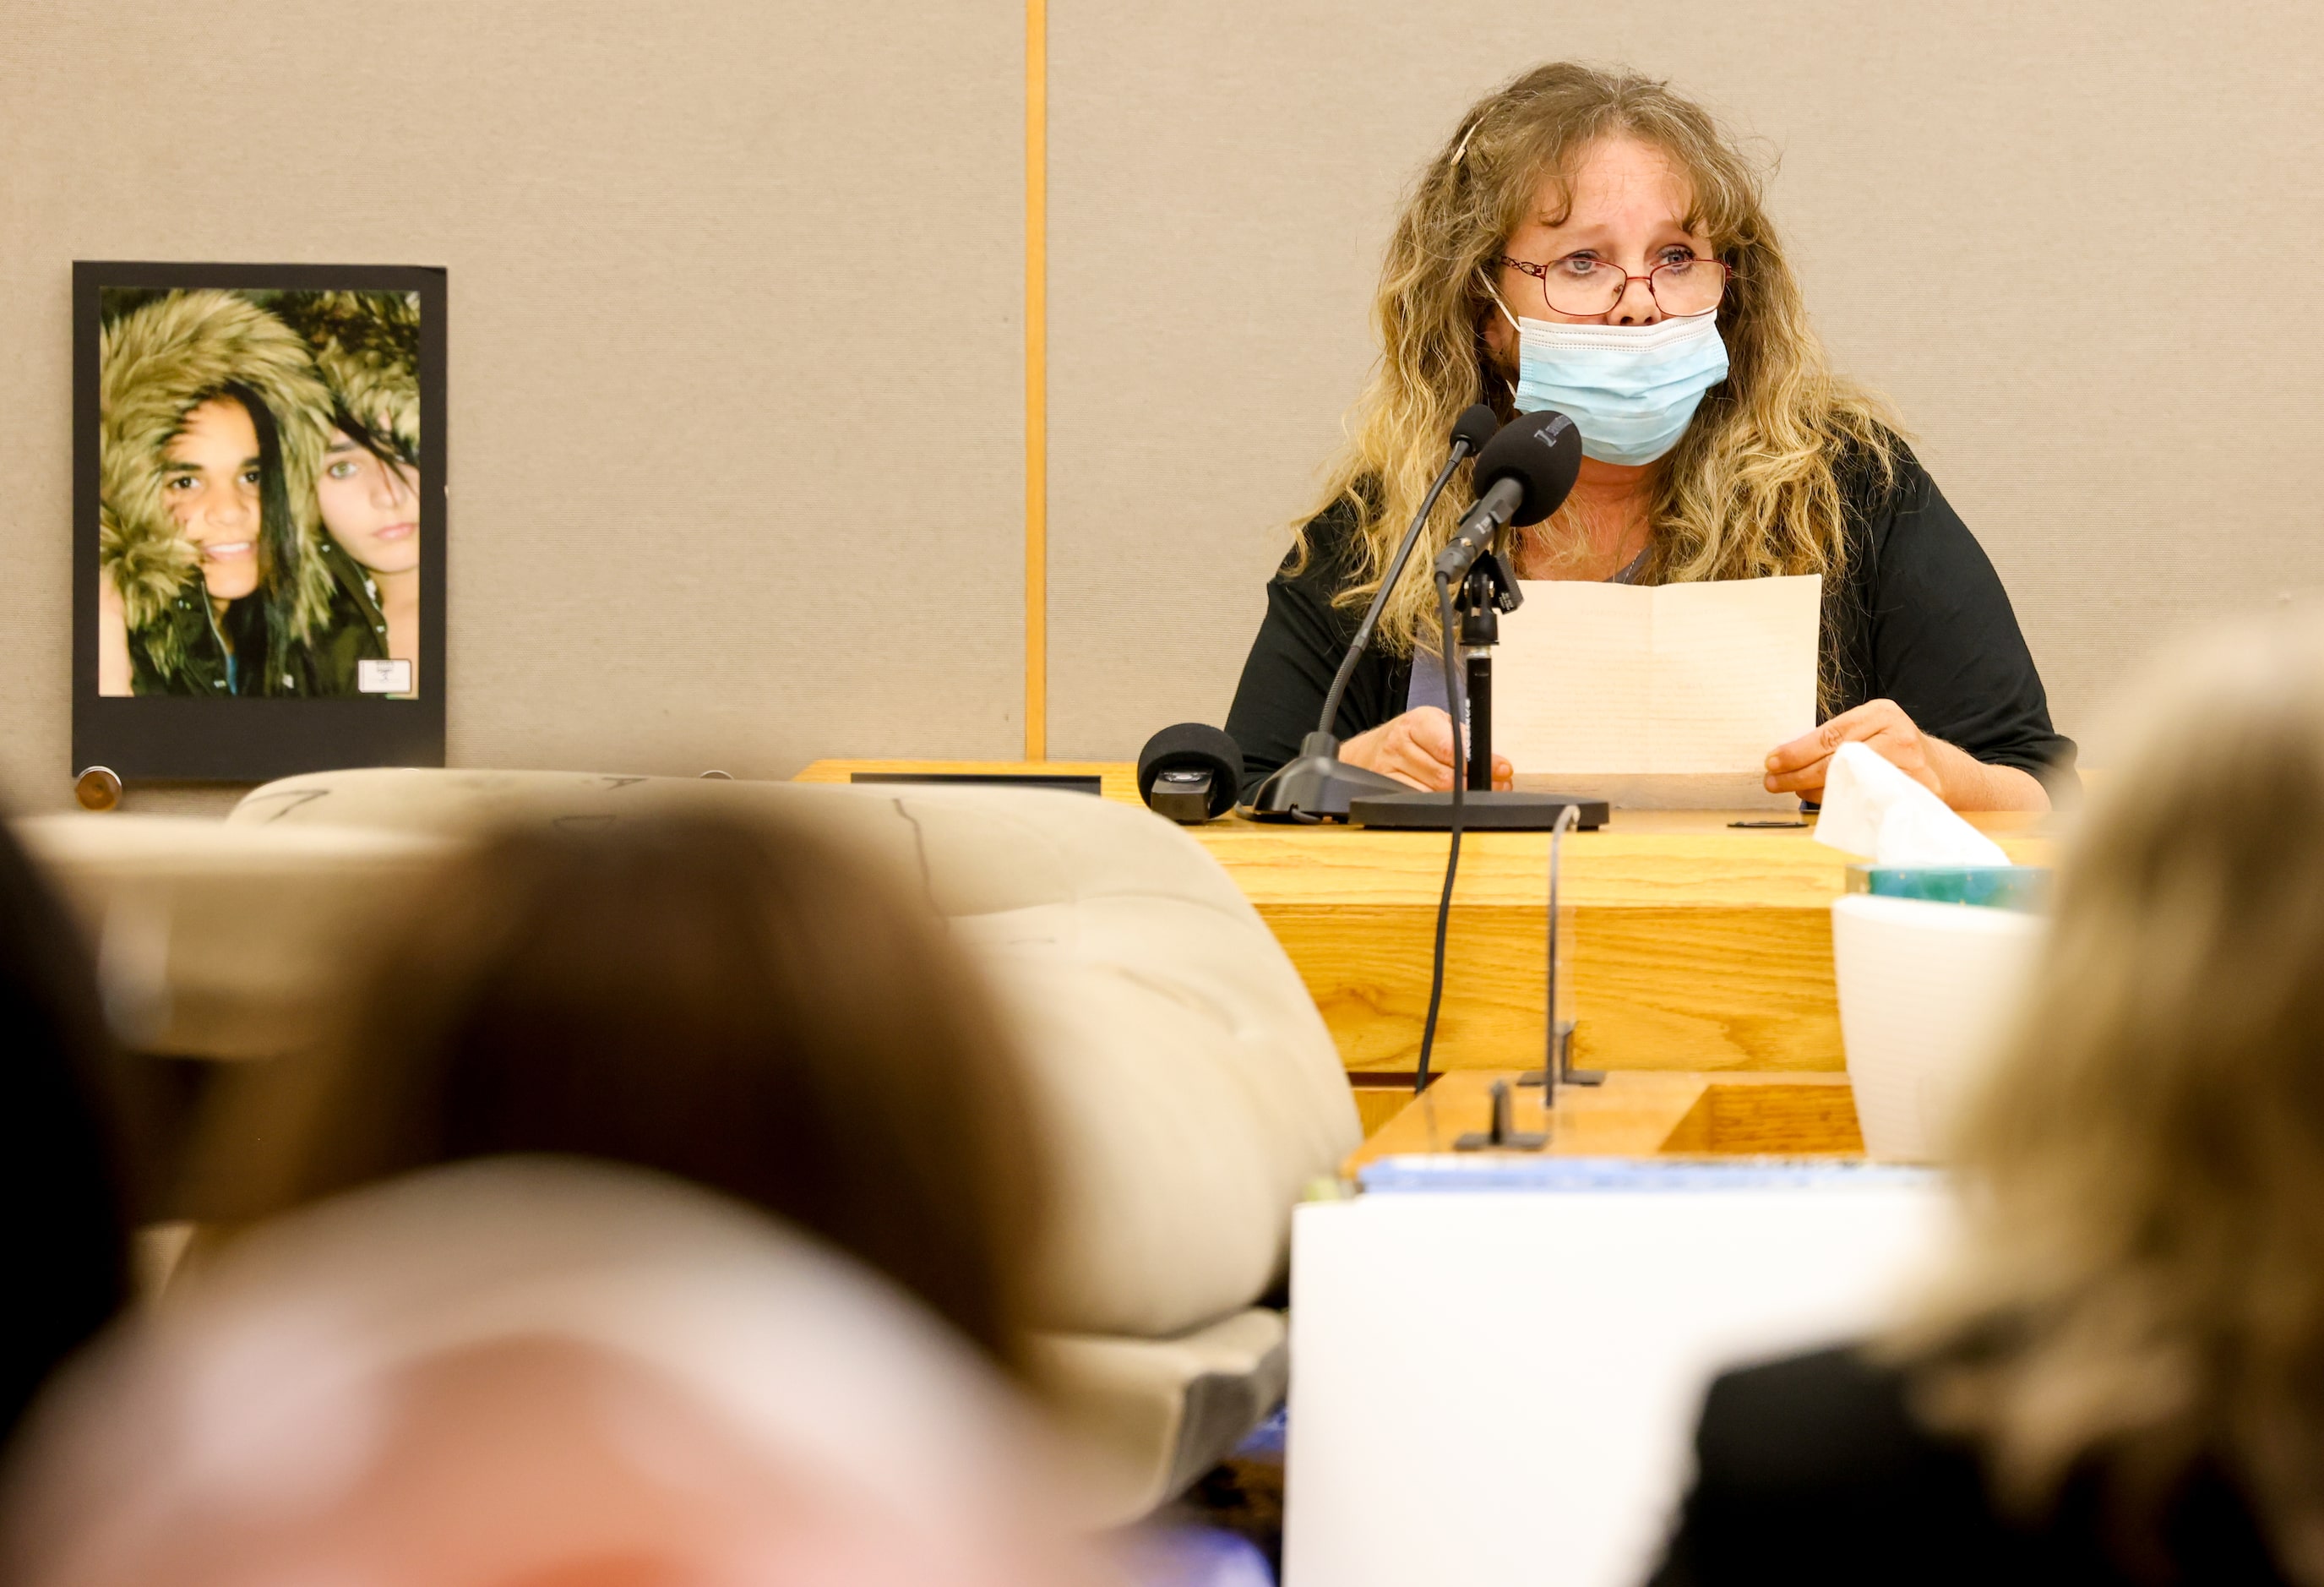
xmin=98 ymin=286 xmax=423 ymax=700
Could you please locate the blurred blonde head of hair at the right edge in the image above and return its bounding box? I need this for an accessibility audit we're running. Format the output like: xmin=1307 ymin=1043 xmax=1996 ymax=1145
xmin=1903 ymin=620 xmax=2324 ymax=1580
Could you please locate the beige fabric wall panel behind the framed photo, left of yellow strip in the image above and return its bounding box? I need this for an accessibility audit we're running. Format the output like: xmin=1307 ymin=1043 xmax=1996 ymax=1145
xmin=0 ymin=0 xmax=1025 ymax=806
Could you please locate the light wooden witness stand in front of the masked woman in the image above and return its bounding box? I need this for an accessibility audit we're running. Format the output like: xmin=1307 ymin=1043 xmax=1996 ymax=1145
xmin=799 ymin=760 xmax=2055 ymax=1153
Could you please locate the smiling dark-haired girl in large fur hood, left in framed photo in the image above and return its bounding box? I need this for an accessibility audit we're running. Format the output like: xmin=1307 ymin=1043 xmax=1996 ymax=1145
xmin=98 ymin=291 xmax=353 ymax=697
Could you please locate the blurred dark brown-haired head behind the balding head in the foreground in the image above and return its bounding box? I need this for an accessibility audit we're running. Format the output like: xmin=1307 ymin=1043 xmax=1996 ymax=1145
xmin=214 ymin=813 xmax=1041 ymax=1364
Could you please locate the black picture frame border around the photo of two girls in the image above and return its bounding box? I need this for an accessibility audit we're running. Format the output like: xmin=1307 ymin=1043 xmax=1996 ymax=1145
xmin=72 ymin=260 xmax=451 ymax=783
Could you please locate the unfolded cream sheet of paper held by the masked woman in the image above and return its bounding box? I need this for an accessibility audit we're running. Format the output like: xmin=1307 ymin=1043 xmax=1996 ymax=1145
xmin=1492 ymin=574 xmax=1825 ymax=785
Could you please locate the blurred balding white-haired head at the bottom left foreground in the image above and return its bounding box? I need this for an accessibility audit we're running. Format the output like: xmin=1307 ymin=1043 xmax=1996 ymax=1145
xmin=5 ymin=1157 xmax=1090 ymax=1587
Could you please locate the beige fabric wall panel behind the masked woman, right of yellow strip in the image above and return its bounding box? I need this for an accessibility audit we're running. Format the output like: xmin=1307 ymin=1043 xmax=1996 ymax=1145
xmin=1050 ymin=0 xmax=2324 ymax=757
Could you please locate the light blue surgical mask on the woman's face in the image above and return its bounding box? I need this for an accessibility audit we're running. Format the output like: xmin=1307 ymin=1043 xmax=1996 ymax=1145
xmin=1501 ymin=307 xmax=1727 ymax=462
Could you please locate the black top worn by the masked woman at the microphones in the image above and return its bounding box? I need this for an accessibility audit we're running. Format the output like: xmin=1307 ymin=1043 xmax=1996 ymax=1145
xmin=1227 ymin=446 xmax=2073 ymax=794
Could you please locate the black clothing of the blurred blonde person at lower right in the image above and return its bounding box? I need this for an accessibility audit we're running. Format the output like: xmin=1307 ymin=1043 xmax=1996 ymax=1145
xmin=1652 ymin=1350 xmax=2284 ymax=1587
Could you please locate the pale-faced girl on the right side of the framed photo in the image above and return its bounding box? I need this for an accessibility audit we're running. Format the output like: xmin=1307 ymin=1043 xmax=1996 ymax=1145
xmin=275 ymin=292 xmax=421 ymax=690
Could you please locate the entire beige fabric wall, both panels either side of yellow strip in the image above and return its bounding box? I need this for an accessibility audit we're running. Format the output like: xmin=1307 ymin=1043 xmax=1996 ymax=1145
xmin=22 ymin=0 xmax=2324 ymax=804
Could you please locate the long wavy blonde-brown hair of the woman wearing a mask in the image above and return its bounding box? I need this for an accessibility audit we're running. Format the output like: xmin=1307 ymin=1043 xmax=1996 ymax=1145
xmin=1297 ymin=60 xmax=1897 ymax=653
